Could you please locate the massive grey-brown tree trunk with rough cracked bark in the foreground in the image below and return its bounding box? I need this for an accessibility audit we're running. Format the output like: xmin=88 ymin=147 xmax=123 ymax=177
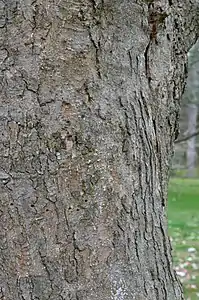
xmin=0 ymin=0 xmax=197 ymax=300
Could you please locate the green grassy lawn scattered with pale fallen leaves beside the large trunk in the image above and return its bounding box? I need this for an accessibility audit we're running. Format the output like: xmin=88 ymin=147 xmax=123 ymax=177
xmin=168 ymin=178 xmax=199 ymax=300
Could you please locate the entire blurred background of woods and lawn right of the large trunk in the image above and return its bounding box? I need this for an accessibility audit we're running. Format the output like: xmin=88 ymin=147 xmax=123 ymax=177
xmin=168 ymin=41 xmax=199 ymax=300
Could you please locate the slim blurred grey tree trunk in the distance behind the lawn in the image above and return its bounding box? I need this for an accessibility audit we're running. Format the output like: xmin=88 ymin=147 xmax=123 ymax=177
xmin=187 ymin=103 xmax=198 ymax=177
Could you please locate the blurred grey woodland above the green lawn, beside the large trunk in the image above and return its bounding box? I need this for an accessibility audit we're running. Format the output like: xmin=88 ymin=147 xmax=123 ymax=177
xmin=173 ymin=41 xmax=199 ymax=177
